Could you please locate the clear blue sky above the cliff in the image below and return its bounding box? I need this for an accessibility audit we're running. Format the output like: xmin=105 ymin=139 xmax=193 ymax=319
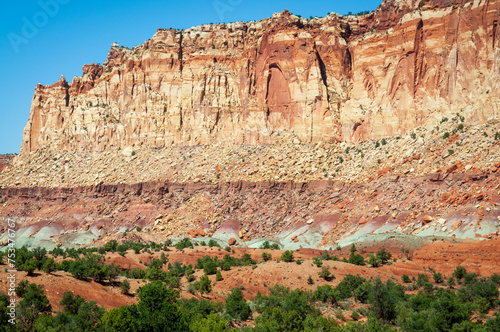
xmin=0 ymin=0 xmax=381 ymax=154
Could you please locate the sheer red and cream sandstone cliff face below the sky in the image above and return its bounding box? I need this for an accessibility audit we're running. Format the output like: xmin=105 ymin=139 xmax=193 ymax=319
xmin=21 ymin=0 xmax=500 ymax=153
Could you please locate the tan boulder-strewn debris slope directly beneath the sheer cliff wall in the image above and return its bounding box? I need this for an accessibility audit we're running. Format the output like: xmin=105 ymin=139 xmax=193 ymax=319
xmin=0 ymin=118 xmax=500 ymax=188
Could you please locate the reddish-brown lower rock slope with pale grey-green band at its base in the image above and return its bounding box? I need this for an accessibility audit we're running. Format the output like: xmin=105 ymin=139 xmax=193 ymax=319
xmin=0 ymin=158 xmax=500 ymax=248
